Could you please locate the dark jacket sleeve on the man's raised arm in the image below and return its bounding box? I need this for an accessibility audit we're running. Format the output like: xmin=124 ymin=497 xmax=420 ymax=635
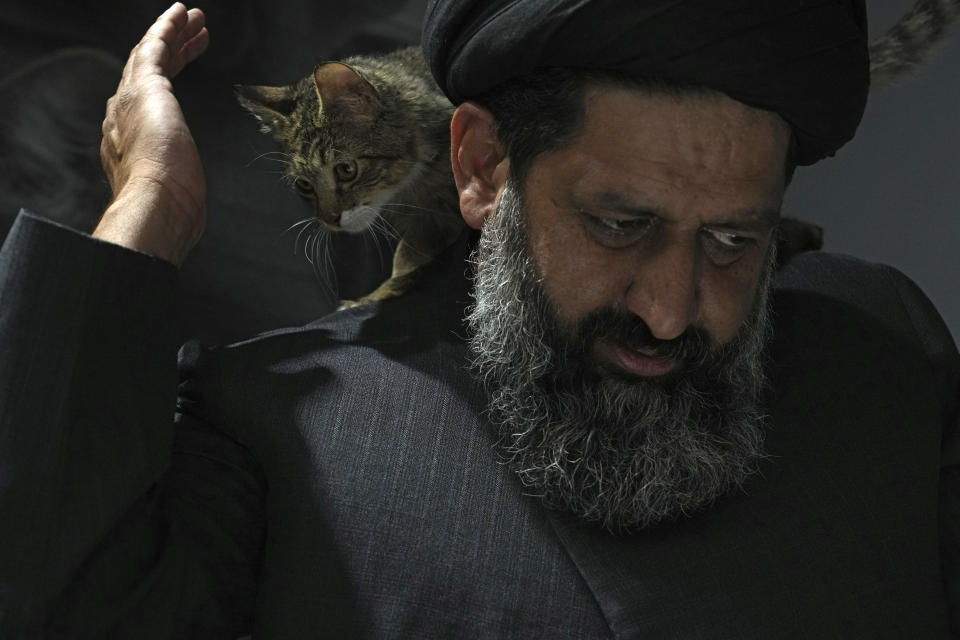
xmin=0 ymin=212 xmax=263 ymax=638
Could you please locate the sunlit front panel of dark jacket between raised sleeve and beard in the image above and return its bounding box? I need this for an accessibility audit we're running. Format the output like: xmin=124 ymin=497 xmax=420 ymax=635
xmin=187 ymin=234 xmax=609 ymax=638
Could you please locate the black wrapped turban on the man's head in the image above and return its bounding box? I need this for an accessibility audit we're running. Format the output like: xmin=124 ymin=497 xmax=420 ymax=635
xmin=423 ymin=0 xmax=870 ymax=164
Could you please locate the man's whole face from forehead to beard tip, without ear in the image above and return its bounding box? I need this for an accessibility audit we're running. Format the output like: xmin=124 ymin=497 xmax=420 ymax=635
xmin=468 ymin=90 xmax=788 ymax=530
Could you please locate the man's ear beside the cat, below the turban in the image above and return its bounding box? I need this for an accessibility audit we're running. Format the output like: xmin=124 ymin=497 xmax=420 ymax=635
xmin=450 ymin=102 xmax=510 ymax=229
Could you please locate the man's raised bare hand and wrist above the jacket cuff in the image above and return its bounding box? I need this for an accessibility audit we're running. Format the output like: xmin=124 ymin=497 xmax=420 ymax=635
xmin=93 ymin=2 xmax=209 ymax=266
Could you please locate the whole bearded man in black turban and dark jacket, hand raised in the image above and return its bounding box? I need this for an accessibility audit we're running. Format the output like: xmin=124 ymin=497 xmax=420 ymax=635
xmin=0 ymin=0 xmax=960 ymax=638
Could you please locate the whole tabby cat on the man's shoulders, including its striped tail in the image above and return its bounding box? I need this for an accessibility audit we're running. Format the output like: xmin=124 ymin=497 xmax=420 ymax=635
xmin=236 ymin=0 xmax=960 ymax=306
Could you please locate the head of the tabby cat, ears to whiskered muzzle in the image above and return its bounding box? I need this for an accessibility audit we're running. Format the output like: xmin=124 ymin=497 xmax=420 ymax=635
xmin=235 ymin=62 xmax=424 ymax=232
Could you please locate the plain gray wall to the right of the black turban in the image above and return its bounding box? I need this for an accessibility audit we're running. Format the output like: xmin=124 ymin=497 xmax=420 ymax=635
xmin=784 ymin=0 xmax=960 ymax=340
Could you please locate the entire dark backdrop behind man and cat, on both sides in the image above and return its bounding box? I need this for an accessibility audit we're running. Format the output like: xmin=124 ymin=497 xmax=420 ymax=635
xmin=0 ymin=0 xmax=960 ymax=343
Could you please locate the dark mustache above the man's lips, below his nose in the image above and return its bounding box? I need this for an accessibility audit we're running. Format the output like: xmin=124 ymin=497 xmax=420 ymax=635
xmin=574 ymin=307 xmax=721 ymax=367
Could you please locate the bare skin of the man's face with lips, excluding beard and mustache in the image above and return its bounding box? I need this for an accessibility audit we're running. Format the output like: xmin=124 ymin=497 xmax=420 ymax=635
xmin=523 ymin=88 xmax=789 ymax=364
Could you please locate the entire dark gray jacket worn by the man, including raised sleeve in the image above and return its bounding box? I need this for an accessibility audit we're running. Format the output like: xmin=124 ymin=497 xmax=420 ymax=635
xmin=0 ymin=215 xmax=960 ymax=639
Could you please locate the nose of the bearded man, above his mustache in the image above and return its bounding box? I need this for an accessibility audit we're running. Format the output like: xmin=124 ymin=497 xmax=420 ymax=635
xmin=626 ymin=242 xmax=701 ymax=340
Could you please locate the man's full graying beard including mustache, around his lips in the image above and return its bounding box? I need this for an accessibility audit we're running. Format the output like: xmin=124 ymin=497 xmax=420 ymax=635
xmin=467 ymin=179 xmax=773 ymax=531
